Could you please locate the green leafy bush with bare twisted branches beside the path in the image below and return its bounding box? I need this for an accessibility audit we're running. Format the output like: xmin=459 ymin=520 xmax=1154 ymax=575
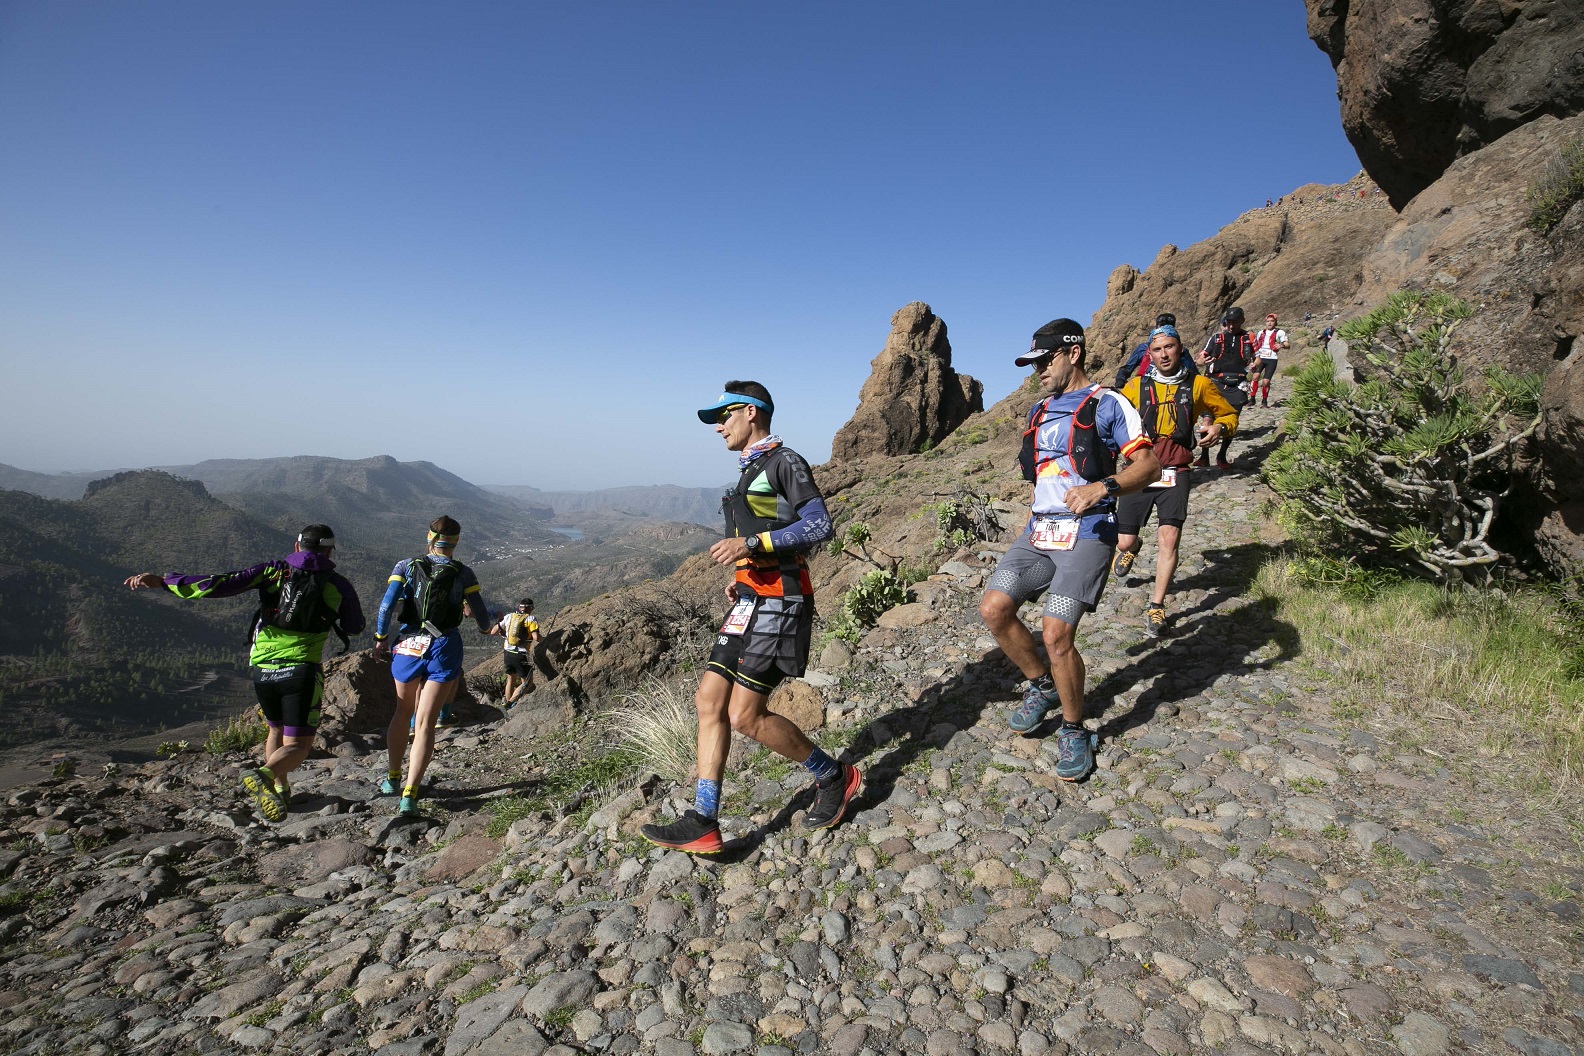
xmin=1266 ymin=291 xmax=1541 ymax=583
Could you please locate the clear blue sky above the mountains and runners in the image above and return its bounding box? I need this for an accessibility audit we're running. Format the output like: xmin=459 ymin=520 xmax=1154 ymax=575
xmin=0 ymin=0 xmax=1359 ymax=488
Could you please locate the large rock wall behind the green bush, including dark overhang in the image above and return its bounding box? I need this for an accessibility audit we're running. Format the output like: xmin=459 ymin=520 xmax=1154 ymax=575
xmin=1307 ymin=0 xmax=1584 ymax=573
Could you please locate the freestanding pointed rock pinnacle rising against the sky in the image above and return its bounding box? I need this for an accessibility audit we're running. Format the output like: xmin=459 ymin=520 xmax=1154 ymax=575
xmin=830 ymin=301 xmax=984 ymax=461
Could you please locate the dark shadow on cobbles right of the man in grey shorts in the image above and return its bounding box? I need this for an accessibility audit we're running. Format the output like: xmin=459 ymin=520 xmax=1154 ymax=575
xmin=1085 ymin=543 xmax=1302 ymax=739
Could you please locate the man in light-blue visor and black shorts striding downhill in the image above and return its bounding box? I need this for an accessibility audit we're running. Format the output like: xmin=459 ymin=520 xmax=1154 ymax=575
xmin=640 ymin=382 xmax=863 ymax=855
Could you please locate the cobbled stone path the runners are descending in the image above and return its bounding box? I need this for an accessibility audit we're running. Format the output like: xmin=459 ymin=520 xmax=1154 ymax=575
xmin=0 ymin=398 xmax=1584 ymax=1056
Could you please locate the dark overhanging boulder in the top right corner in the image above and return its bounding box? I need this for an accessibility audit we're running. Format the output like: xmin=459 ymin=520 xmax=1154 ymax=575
xmin=1305 ymin=0 xmax=1584 ymax=209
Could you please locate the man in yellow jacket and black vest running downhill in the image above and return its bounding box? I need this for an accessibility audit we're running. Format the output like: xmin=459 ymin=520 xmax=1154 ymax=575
xmin=1110 ymin=326 xmax=1237 ymax=638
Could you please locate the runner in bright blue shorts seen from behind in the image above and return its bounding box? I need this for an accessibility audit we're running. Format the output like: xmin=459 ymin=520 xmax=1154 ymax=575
xmin=374 ymin=515 xmax=494 ymax=815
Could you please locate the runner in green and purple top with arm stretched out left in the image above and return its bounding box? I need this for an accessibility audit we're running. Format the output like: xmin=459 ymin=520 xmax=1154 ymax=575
xmin=127 ymin=524 xmax=363 ymax=822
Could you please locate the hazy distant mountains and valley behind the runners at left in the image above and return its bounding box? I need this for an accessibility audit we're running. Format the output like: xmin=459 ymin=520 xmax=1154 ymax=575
xmin=0 ymin=456 xmax=719 ymax=747
